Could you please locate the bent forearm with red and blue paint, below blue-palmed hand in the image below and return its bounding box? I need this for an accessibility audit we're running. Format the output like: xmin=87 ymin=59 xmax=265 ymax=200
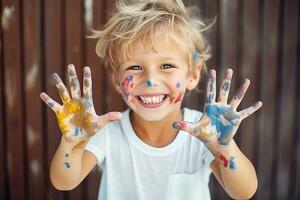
xmin=207 ymin=140 xmax=258 ymax=199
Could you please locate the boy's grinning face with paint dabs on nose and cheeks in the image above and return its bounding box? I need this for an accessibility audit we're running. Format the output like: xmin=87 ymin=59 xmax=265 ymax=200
xmin=117 ymin=34 xmax=200 ymax=121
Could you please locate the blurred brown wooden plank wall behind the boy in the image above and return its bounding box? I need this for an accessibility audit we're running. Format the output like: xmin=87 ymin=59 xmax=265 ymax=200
xmin=0 ymin=0 xmax=300 ymax=200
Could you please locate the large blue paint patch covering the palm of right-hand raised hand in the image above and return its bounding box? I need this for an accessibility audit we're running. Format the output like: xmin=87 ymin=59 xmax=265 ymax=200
xmin=206 ymin=104 xmax=239 ymax=145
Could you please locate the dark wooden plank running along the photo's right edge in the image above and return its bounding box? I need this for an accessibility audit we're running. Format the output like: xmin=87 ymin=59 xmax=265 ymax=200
xmin=276 ymin=0 xmax=299 ymax=199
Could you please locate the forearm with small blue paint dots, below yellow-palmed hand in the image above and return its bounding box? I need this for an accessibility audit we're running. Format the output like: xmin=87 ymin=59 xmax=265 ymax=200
xmin=50 ymin=137 xmax=84 ymax=190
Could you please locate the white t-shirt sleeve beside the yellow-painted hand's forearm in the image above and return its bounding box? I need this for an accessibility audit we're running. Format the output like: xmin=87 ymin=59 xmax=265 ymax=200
xmin=85 ymin=129 xmax=106 ymax=166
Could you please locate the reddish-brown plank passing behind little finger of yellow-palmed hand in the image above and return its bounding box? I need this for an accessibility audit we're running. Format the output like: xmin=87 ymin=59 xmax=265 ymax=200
xmin=43 ymin=0 xmax=64 ymax=199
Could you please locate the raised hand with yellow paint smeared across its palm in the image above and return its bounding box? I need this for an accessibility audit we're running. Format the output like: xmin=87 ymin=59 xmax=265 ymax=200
xmin=40 ymin=65 xmax=122 ymax=150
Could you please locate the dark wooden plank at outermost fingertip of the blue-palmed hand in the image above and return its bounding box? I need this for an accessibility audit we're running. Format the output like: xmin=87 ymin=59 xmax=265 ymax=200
xmin=256 ymin=0 xmax=279 ymax=199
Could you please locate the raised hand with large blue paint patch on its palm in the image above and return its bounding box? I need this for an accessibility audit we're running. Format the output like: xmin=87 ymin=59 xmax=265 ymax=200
xmin=173 ymin=69 xmax=262 ymax=146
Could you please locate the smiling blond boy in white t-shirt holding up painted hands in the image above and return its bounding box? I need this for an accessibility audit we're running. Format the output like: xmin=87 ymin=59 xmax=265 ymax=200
xmin=41 ymin=0 xmax=262 ymax=200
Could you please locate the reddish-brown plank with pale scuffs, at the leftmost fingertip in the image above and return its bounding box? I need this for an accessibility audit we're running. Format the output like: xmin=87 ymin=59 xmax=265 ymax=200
xmin=22 ymin=0 xmax=48 ymax=199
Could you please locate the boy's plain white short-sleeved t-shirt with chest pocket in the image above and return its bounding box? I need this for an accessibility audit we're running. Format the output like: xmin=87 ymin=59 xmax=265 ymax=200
xmin=86 ymin=108 xmax=214 ymax=200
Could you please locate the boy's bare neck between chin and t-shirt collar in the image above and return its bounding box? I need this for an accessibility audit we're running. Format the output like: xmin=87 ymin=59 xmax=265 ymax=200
xmin=130 ymin=108 xmax=183 ymax=147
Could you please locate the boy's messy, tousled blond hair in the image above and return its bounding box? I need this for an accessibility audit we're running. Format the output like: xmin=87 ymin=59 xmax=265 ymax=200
xmin=93 ymin=0 xmax=210 ymax=78
